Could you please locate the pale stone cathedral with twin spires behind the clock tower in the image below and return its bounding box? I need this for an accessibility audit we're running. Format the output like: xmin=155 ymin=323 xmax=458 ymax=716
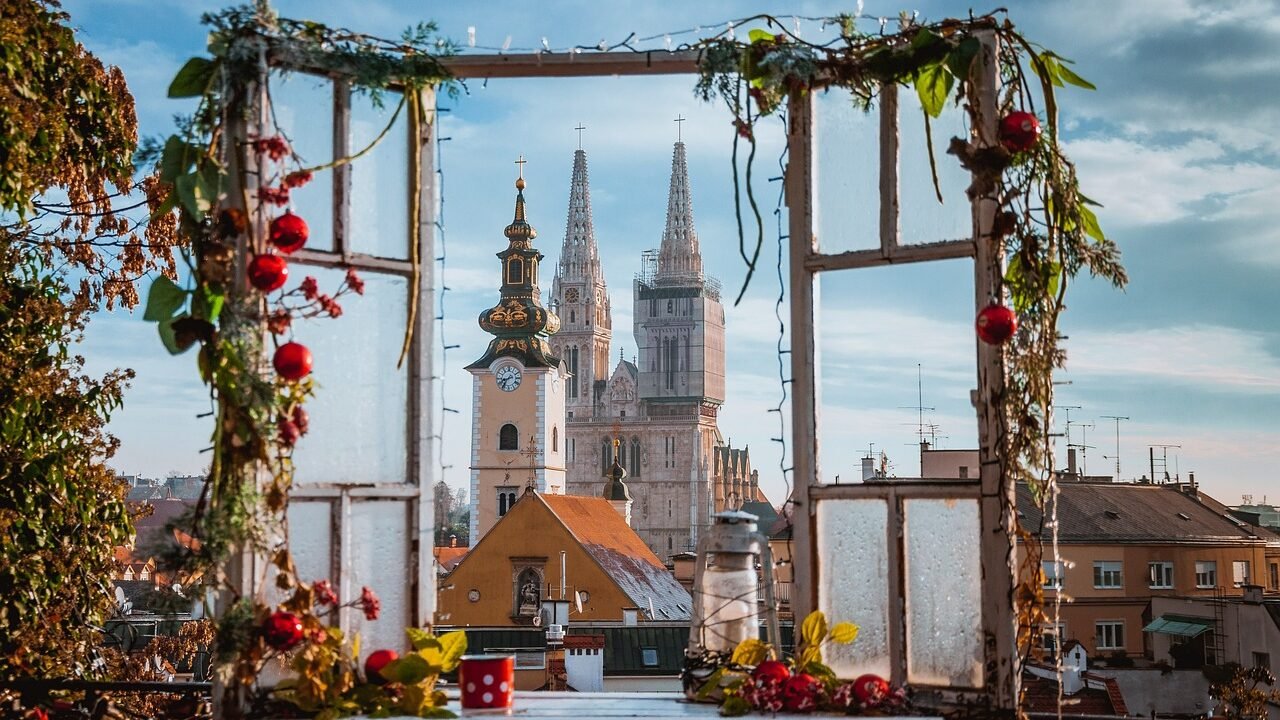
xmin=552 ymin=142 xmax=764 ymax=557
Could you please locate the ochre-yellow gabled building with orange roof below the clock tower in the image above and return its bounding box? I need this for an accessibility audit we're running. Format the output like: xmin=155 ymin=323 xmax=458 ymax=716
xmin=436 ymin=491 xmax=692 ymax=628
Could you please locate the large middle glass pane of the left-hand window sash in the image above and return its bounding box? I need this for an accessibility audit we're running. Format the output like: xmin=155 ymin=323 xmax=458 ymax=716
xmin=289 ymin=265 xmax=408 ymax=483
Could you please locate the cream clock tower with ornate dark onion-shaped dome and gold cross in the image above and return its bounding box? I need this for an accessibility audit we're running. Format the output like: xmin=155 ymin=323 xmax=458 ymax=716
xmin=467 ymin=160 xmax=567 ymax=547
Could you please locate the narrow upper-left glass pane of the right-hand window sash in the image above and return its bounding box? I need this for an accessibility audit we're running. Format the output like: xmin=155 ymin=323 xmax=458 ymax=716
xmin=814 ymin=90 xmax=879 ymax=252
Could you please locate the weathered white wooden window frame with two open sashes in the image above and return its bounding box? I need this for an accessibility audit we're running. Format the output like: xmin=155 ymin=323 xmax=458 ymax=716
xmin=257 ymin=31 xmax=1020 ymax=710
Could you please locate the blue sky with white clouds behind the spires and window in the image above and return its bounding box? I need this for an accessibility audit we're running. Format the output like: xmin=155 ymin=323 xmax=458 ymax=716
xmin=64 ymin=0 xmax=1280 ymax=503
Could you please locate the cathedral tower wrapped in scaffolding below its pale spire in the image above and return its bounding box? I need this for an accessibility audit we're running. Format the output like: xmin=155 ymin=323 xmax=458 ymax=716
xmin=634 ymin=142 xmax=724 ymax=407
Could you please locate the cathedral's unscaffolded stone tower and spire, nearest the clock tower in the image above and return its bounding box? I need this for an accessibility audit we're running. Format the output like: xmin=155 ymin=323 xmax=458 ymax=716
xmin=552 ymin=149 xmax=613 ymax=419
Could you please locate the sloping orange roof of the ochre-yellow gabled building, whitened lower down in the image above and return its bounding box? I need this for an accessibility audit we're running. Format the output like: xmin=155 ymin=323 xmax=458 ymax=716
xmin=535 ymin=493 xmax=692 ymax=620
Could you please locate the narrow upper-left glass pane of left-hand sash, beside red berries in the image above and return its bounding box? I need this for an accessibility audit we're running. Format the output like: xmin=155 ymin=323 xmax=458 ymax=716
xmin=271 ymin=73 xmax=333 ymax=251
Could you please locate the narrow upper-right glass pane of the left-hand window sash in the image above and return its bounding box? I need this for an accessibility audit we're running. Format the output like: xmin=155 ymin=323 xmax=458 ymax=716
xmin=349 ymin=92 xmax=410 ymax=258
